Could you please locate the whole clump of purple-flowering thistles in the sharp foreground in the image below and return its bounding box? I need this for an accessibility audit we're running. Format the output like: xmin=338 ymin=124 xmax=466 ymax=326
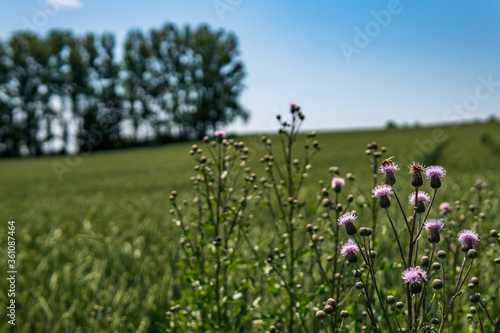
xmin=168 ymin=104 xmax=500 ymax=333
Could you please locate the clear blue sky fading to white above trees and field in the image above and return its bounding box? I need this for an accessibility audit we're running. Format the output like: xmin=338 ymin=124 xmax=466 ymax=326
xmin=0 ymin=0 xmax=500 ymax=132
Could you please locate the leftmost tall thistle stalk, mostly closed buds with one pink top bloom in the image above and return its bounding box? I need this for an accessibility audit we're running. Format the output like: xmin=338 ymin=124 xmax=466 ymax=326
xmin=170 ymin=131 xmax=256 ymax=332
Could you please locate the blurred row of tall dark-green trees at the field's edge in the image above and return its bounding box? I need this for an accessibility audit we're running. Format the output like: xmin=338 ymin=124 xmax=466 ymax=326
xmin=0 ymin=24 xmax=248 ymax=157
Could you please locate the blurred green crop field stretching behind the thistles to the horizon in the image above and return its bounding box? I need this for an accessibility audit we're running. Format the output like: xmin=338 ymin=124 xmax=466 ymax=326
xmin=0 ymin=122 xmax=500 ymax=332
